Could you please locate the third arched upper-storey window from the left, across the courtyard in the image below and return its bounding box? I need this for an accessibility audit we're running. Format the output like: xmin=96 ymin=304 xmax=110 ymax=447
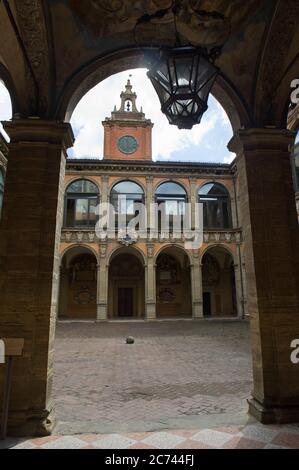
xmin=155 ymin=181 xmax=187 ymax=230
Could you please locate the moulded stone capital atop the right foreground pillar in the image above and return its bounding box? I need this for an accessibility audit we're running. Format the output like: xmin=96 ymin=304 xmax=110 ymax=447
xmin=228 ymin=127 xmax=295 ymax=154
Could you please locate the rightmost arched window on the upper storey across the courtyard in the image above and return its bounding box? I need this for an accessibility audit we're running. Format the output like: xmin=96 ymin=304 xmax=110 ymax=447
xmin=199 ymin=183 xmax=232 ymax=229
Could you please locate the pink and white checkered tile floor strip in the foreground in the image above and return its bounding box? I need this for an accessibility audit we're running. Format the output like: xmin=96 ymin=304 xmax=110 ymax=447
xmin=7 ymin=422 xmax=299 ymax=449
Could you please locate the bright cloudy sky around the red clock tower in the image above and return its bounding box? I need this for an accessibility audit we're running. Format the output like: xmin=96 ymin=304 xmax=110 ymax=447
xmin=0 ymin=69 xmax=298 ymax=163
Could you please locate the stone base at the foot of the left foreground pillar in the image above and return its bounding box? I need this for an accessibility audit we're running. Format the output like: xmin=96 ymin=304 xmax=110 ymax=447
xmin=3 ymin=409 xmax=56 ymax=437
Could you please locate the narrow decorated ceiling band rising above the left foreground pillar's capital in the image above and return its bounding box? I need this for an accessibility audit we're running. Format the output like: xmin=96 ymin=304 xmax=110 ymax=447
xmin=15 ymin=0 xmax=50 ymax=117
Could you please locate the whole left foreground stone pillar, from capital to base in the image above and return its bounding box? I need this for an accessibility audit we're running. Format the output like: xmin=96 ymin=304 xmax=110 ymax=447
xmin=0 ymin=119 xmax=74 ymax=436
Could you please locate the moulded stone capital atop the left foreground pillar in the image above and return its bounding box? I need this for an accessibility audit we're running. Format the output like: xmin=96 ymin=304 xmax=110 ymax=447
xmin=3 ymin=119 xmax=75 ymax=150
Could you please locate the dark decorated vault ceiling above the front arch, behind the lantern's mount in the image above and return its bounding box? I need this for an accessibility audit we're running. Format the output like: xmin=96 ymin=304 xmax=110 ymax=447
xmin=69 ymin=0 xmax=260 ymax=47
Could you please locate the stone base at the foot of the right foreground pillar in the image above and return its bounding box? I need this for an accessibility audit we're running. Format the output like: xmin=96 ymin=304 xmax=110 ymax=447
xmin=248 ymin=398 xmax=299 ymax=424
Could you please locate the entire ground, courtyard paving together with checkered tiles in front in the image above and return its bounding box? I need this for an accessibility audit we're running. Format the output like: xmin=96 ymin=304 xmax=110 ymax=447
xmin=4 ymin=320 xmax=299 ymax=449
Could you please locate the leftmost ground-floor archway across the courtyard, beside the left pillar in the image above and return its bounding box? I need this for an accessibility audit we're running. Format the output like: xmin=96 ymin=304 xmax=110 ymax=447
xmin=58 ymin=247 xmax=97 ymax=320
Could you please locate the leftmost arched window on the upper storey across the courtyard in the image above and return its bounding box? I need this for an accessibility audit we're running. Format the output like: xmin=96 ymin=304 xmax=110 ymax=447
xmin=65 ymin=180 xmax=99 ymax=228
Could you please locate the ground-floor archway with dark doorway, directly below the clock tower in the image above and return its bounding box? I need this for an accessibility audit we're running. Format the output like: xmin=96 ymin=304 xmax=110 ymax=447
xmin=108 ymin=249 xmax=145 ymax=319
